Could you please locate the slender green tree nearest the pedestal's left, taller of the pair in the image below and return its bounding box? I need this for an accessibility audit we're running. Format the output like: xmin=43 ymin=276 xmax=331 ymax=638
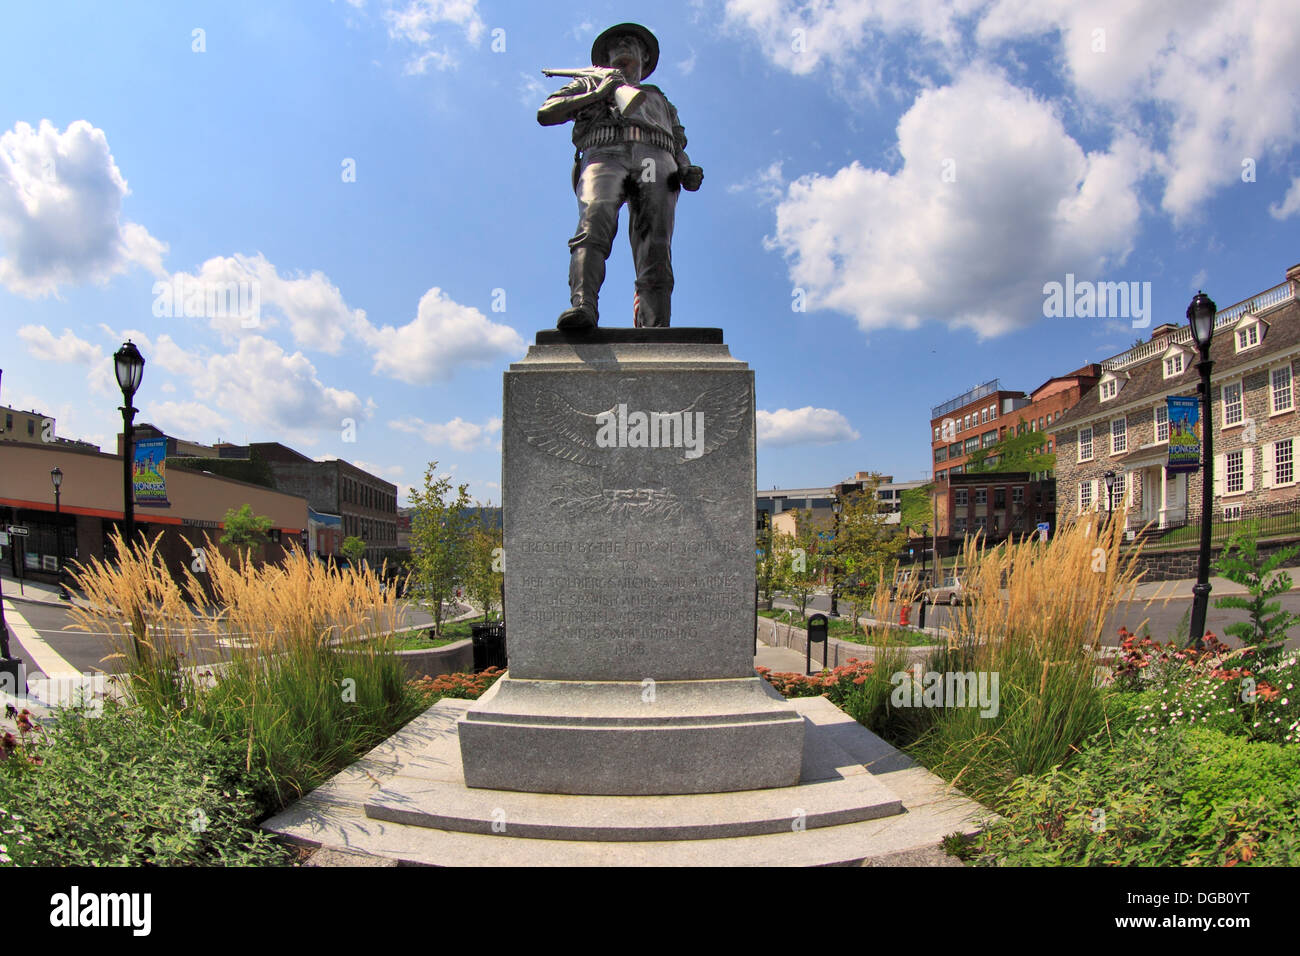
xmin=410 ymin=462 xmax=473 ymax=633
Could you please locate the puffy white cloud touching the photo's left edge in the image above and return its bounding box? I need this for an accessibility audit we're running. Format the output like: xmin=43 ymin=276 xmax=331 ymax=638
xmin=0 ymin=120 xmax=166 ymax=297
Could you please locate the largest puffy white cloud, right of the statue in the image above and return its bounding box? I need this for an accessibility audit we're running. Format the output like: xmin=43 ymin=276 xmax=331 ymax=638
xmin=772 ymin=70 xmax=1151 ymax=337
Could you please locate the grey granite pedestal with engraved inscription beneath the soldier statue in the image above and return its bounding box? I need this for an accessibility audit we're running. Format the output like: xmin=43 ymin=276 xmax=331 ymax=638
xmin=458 ymin=329 xmax=803 ymax=795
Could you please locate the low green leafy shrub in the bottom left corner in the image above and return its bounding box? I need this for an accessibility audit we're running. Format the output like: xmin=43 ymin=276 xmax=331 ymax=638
xmin=0 ymin=702 xmax=291 ymax=866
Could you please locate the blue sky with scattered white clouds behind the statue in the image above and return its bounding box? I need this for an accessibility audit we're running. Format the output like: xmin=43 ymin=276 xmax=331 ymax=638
xmin=0 ymin=0 xmax=1300 ymax=501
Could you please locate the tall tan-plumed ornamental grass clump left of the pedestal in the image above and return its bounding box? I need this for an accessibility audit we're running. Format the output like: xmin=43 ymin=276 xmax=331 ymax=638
xmin=72 ymin=535 xmax=423 ymax=805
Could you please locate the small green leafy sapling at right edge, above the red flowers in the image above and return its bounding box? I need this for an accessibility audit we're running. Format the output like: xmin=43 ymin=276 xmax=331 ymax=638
xmin=1197 ymin=522 xmax=1300 ymax=653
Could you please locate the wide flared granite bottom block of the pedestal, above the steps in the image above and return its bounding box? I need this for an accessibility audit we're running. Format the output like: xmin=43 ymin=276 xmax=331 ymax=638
xmin=458 ymin=675 xmax=803 ymax=795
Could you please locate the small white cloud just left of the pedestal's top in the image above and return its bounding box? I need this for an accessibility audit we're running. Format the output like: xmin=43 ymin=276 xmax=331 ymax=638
xmin=367 ymin=287 xmax=524 ymax=385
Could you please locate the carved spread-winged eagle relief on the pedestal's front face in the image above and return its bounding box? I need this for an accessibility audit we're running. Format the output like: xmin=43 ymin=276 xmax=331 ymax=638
xmin=520 ymin=385 xmax=749 ymax=519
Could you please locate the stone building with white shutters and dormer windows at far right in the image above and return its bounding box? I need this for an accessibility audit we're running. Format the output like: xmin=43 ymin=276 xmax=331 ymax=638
xmin=1056 ymin=265 xmax=1300 ymax=528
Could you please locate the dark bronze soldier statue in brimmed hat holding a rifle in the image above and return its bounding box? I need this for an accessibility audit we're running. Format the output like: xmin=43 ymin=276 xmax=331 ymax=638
xmin=537 ymin=23 xmax=705 ymax=329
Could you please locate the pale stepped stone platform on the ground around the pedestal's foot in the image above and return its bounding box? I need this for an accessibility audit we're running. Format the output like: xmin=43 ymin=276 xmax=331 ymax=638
xmin=263 ymin=697 xmax=991 ymax=868
